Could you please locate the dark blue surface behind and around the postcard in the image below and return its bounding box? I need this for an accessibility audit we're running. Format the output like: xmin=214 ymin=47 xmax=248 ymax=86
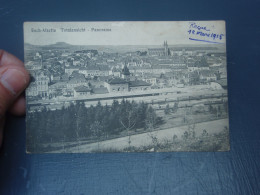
xmin=0 ymin=0 xmax=260 ymax=195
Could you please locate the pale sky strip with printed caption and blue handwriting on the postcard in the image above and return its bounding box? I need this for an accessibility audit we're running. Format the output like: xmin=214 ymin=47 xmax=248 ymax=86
xmin=24 ymin=21 xmax=226 ymax=45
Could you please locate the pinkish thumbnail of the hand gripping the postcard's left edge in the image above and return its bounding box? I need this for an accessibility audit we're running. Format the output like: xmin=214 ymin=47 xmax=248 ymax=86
xmin=0 ymin=69 xmax=26 ymax=95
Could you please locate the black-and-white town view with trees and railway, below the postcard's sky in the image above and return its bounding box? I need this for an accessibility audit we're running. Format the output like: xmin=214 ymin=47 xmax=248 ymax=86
xmin=25 ymin=40 xmax=229 ymax=152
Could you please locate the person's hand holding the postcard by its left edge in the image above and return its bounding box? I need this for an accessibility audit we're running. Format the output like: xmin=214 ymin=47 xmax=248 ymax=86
xmin=0 ymin=50 xmax=30 ymax=147
